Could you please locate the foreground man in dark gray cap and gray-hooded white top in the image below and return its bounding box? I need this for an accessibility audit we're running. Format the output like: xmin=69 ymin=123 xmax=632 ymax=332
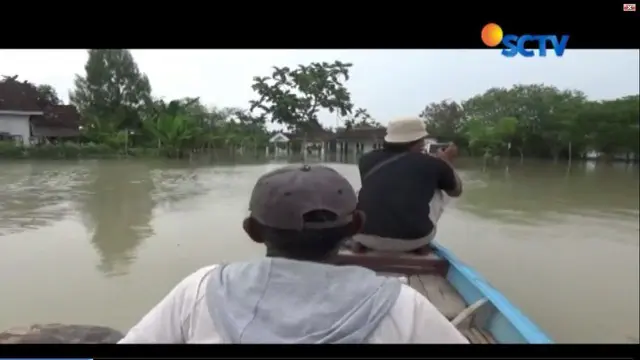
xmin=120 ymin=165 xmax=468 ymax=344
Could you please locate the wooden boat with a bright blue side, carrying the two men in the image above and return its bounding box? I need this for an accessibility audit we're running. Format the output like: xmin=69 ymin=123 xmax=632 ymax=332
xmin=336 ymin=244 xmax=552 ymax=344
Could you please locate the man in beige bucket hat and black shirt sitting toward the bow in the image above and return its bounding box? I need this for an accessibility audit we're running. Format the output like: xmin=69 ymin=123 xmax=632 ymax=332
xmin=353 ymin=118 xmax=462 ymax=252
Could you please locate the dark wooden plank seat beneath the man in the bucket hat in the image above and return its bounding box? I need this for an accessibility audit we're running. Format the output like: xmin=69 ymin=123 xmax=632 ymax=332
xmin=333 ymin=248 xmax=449 ymax=276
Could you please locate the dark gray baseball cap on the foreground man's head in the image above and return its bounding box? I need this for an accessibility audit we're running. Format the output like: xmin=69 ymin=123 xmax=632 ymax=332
xmin=249 ymin=165 xmax=358 ymax=230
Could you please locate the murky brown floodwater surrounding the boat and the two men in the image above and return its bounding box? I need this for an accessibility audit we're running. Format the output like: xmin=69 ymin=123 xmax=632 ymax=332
xmin=0 ymin=161 xmax=639 ymax=342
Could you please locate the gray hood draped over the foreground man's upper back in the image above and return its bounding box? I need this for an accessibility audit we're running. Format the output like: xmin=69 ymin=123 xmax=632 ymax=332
xmin=206 ymin=258 xmax=402 ymax=344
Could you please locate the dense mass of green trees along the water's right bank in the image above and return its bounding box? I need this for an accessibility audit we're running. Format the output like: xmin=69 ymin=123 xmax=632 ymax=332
xmin=442 ymin=84 xmax=639 ymax=160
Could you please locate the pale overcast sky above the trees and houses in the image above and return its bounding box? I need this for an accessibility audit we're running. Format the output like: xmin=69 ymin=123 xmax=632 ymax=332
xmin=0 ymin=50 xmax=640 ymax=125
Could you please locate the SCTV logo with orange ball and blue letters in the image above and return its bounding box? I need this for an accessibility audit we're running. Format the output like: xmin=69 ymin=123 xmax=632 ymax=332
xmin=482 ymin=23 xmax=569 ymax=57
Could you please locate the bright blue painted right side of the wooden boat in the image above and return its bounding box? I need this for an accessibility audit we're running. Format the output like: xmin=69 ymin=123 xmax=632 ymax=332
xmin=433 ymin=243 xmax=553 ymax=344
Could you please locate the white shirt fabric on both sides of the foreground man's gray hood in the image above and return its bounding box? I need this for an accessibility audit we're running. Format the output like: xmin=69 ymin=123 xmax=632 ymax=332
xmin=119 ymin=265 xmax=469 ymax=344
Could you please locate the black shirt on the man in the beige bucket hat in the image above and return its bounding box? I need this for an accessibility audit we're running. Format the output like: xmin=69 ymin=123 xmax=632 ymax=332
xmin=358 ymin=150 xmax=446 ymax=239
